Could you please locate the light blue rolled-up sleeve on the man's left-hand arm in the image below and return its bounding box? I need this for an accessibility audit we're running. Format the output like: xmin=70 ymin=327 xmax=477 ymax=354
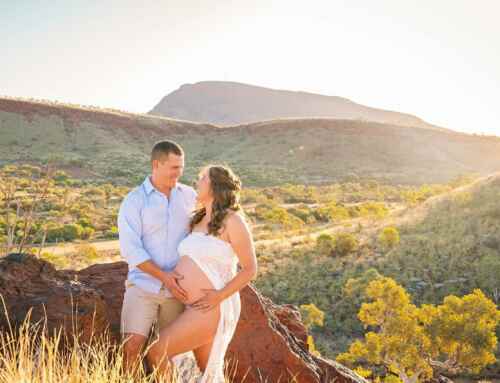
xmin=118 ymin=195 xmax=151 ymax=268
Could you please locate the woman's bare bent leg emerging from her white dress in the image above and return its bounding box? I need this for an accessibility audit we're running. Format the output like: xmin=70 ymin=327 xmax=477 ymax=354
xmin=147 ymin=306 xmax=220 ymax=374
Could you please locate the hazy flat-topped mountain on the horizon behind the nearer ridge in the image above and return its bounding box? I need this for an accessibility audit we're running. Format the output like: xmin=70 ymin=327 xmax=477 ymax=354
xmin=149 ymin=81 xmax=446 ymax=130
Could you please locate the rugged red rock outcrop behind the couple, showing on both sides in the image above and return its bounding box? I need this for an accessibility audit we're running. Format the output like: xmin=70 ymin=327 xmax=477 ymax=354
xmin=0 ymin=254 xmax=364 ymax=383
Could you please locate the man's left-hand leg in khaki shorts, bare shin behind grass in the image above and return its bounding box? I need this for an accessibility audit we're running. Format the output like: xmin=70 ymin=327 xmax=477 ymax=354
xmin=121 ymin=282 xmax=159 ymax=374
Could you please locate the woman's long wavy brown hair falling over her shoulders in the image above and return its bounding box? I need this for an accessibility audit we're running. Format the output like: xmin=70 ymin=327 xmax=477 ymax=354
xmin=189 ymin=164 xmax=244 ymax=237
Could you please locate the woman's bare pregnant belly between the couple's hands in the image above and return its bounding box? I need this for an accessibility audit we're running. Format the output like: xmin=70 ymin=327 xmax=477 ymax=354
xmin=175 ymin=256 xmax=214 ymax=304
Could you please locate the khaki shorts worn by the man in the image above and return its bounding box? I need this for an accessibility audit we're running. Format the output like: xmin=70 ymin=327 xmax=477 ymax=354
xmin=120 ymin=281 xmax=185 ymax=337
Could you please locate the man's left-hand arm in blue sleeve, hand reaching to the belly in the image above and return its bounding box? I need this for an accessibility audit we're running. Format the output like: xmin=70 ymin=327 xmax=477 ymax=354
xmin=118 ymin=196 xmax=187 ymax=300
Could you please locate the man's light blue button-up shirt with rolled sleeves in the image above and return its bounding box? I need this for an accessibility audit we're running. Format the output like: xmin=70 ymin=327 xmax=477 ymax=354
xmin=118 ymin=176 xmax=197 ymax=296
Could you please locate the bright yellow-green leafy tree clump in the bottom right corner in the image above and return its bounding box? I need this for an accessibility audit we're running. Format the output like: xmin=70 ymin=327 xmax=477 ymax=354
xmin=337 ymin=277 xmax=500 ymax=383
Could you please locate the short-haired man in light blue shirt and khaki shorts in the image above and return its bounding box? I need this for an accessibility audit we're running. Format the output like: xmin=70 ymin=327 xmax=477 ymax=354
xmin=118 ymin=141 xmax=197 ymax=372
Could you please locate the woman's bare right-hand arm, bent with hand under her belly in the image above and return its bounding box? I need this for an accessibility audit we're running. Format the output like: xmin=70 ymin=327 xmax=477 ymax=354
xmin=192 ymin=213 xmax=257 ymax=311
